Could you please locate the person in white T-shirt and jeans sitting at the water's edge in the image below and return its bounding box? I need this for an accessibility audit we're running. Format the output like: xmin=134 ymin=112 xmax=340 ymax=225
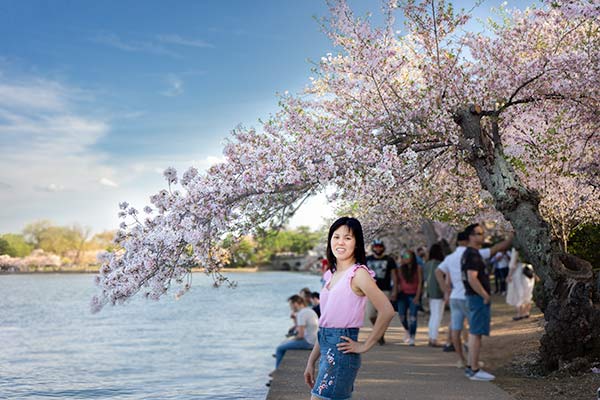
xmin=275 ymin=295 xmax=319 ymax=368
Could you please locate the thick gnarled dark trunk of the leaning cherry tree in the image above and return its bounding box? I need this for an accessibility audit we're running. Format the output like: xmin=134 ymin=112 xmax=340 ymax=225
xmin=455 ymin=106 xmax=600 ymax=371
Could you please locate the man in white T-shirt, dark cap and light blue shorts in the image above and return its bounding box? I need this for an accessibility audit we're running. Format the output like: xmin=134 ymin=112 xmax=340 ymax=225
xmin=435 ymin=232 xmax=512 ymax=368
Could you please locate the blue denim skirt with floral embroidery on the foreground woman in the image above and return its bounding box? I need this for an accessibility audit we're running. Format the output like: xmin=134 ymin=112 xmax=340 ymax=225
xmin=311 ymin=328 xmax=360 ymax=400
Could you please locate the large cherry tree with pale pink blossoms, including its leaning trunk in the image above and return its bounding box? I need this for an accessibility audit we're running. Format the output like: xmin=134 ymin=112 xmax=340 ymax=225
xmin=92 ymin=0 xmax=600 ymax=369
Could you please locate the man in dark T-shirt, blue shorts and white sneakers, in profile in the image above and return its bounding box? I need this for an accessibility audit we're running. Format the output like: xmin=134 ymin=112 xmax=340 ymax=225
xmin=461 ymin=224 xmax=510 ymax=381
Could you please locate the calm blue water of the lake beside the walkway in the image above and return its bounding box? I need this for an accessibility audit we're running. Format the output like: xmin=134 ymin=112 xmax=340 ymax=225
xmin=0 ymin=272 xmax=320 ymax=399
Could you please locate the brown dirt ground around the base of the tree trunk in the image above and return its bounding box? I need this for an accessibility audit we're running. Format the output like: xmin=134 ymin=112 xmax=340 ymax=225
xmin=481 ymin=296 xmax=600 ymax=400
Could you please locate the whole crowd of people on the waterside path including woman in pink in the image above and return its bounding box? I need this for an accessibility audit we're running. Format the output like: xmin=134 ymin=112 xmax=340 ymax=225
xmin=275 ymin=217 xmax=535 ymax=400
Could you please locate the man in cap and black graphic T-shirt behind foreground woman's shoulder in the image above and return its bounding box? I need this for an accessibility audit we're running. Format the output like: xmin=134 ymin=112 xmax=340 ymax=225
xmin=367 ymin=239 xmax=398 ymax=345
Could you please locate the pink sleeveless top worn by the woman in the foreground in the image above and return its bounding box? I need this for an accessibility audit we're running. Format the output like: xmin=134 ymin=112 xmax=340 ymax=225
xmin=319 ymin=264 xmax=375 ymax=328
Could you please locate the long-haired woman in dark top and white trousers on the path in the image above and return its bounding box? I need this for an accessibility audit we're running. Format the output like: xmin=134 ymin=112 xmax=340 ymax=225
xmin=425 ymin=243 xmax=445 ymax=347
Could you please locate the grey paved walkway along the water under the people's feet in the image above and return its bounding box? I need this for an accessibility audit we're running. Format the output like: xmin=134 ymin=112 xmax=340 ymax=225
xmin=267 ymin=314 xmax=513 ymax=400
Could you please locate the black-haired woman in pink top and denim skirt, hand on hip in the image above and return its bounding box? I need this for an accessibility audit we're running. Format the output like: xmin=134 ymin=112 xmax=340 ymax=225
xmin=304 ymin=217 xmax=394 ymax=400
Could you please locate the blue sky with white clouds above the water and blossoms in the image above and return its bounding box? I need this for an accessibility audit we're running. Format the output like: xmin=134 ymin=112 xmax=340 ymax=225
xmin=0 ymin=0 xmax=536 ymax=233
